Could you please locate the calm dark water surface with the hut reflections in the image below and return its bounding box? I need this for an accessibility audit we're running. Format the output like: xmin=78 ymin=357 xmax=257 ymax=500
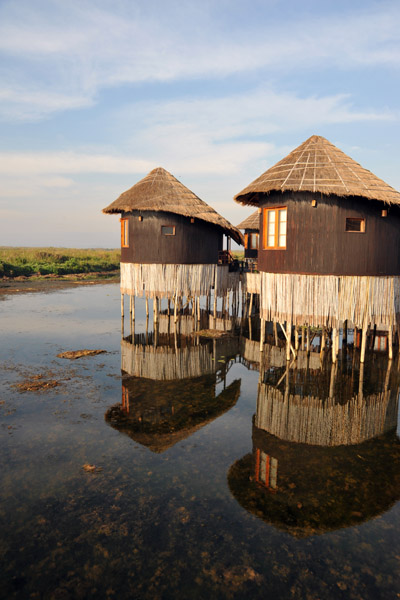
xmin=0 ymin=285 xmax=400 ymax=600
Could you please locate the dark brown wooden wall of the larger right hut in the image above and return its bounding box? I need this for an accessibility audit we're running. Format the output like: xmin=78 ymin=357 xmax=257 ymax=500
xmin=258 ymin=192 xmax=400 ymax=275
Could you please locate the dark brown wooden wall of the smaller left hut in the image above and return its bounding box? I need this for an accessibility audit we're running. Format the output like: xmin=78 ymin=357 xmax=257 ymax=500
xmin=121 ymin=211 xmax=223 ymax=264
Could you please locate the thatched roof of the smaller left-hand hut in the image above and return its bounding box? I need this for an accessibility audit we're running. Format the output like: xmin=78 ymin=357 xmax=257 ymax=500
xmin=103 ymin=167 xmax=243 ymax=244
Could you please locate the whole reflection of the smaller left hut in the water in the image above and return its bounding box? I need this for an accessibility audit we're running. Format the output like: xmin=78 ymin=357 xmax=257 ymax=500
xmin=105 ymin=317 xmax=240 ymax=452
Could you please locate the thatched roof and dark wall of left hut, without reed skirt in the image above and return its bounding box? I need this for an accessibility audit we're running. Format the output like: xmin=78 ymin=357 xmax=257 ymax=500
xmin=103 ymin=167 xmax=243 ymax=264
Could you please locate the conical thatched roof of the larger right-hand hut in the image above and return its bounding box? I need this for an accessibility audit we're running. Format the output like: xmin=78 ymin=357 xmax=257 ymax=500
xmin=234 ymin=135 xmax=400 ymax=206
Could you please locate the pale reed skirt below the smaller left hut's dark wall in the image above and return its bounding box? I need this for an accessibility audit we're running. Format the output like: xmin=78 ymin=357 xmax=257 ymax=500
xmin=121 ymin=263 xmax=240 ymax=299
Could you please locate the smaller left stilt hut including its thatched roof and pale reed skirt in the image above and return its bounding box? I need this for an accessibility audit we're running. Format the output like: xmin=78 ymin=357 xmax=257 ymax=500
xmin=103 ymin=168 xmax=243 ymax=326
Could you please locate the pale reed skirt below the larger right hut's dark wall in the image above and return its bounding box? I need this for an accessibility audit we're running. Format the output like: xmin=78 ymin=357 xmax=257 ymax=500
xmin=260 ymin=273 xmax=400 ymax=328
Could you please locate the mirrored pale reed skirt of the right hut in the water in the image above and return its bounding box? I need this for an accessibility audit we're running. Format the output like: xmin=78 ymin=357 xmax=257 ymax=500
xmin=255 ymin=383 xmax=399 ymax=446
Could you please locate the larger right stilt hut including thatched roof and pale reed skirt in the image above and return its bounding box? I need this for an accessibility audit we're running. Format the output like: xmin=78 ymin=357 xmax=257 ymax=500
xmin=235 ymin=135 xmax=400 ymax=361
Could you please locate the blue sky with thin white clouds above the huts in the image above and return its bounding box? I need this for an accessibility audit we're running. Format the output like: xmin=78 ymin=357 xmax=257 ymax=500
xmin=0 ymin=0 xmax=400 ymax=248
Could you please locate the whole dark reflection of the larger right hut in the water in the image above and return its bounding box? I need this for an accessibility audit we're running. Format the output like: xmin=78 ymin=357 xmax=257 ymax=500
xmin=228 ymin=355 xmax=400 ymax=537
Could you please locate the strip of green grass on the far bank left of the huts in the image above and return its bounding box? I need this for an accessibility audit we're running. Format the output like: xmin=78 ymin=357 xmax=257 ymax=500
xmin=0 ymin=246 xmax=121 ymax=277
